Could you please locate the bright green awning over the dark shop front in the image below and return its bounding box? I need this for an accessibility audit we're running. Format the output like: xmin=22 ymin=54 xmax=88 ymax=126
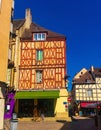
xmin=15 ymin=90 xmax=59 ymax=99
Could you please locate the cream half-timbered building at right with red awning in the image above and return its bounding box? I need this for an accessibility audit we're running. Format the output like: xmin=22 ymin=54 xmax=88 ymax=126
xmin=72 ymin=66 xmax=101 ymax=115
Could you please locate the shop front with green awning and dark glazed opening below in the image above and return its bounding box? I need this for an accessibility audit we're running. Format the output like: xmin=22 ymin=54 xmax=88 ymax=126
xmin=15 ymin=91 xmax=59 ymax=117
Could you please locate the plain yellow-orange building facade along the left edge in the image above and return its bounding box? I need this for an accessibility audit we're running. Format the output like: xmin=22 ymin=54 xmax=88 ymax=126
xmin=0 ymin=0 xmax=14 ymax=129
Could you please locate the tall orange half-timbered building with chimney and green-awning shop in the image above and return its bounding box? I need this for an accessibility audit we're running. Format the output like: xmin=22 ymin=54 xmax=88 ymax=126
xmin=14 ymin=9 xmax=68 ymax=117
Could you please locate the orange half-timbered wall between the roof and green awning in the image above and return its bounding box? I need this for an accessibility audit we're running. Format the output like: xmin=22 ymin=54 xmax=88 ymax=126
xmin=18 ymin=40 xmax=66 ymax=90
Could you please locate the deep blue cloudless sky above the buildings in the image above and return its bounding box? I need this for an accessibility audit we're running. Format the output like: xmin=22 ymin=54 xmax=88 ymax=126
xmin=14 ymin=0 xmax=101 ymax=90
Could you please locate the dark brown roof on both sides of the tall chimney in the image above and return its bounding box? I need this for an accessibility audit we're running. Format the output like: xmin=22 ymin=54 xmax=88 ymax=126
xmin=13 ymin=19 xmax=66 ymax=39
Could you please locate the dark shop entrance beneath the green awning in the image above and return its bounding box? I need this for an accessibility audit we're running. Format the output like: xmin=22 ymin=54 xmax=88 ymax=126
xmin=18 ymin=99 xmax=55 ymax=117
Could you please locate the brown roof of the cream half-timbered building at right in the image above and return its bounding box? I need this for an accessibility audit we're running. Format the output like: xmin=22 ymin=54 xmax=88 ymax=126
xmin=73 ymin=68 xmax=101 ymax=84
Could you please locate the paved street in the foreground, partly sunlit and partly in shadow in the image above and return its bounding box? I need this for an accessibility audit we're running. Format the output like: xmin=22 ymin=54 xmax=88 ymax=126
xmin=5 ymin=118 xmax=97 ymax=130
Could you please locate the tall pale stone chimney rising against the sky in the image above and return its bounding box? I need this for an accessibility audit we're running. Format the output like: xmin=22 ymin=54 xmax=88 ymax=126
xmin=25 ymin=9 xmax=32 ymax=29
